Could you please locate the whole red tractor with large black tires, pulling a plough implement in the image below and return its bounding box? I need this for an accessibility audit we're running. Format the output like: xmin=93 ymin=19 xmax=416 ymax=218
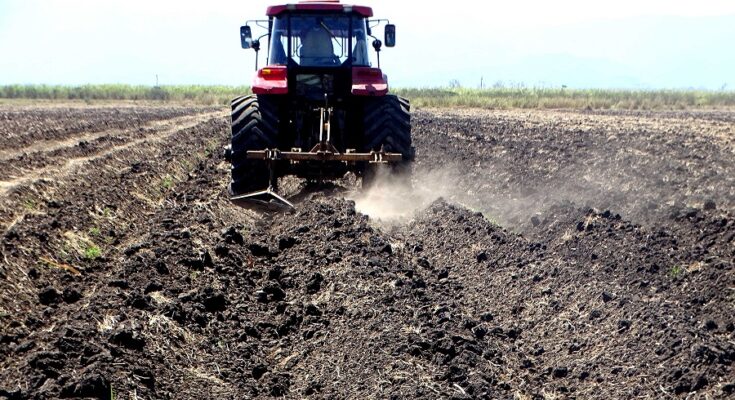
xmin=226 ymin=0 xmax=414 ymax=208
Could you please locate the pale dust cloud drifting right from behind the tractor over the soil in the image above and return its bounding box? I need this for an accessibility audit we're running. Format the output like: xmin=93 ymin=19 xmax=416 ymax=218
xmin=346 ymin=155 xmax=684 ymax=233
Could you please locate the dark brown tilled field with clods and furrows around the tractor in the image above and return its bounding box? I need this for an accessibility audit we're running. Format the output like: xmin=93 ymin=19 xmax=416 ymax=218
xmin=0 ymin=105 xmax=735 ymax=399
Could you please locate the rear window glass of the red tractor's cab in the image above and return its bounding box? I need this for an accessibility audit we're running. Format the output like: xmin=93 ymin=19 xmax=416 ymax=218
xmin=269 ymin=14 xmax=370 ymax=67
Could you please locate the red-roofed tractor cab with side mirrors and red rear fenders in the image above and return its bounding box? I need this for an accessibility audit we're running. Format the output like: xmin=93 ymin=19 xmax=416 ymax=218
xmin=240 ymin=1 xmax=395 ymax=102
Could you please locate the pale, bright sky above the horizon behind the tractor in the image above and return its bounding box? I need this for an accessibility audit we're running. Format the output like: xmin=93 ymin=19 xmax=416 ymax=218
xmin=0 ymin=0 xmax=735 ymax=90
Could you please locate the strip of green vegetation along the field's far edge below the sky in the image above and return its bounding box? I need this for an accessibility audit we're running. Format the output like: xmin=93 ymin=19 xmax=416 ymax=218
xmin=0 ymin=85 xmax=735 ymax=110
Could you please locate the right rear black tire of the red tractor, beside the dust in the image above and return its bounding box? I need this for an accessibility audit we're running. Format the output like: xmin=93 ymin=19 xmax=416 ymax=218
xmin=362 ymin=95 xmax=414 ymax=187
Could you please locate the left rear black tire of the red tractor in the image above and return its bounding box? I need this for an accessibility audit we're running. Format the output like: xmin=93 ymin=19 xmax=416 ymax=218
xmin=230 ymin=95 xmax=279 ymax=195
